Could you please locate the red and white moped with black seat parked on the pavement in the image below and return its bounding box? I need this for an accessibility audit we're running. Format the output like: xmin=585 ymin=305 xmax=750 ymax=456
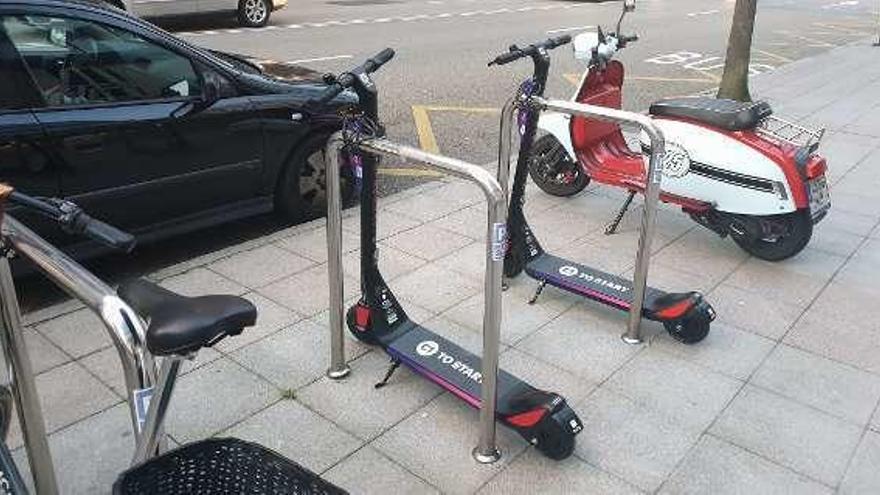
xmin=529 ymin=0 xmax=831 ymax=261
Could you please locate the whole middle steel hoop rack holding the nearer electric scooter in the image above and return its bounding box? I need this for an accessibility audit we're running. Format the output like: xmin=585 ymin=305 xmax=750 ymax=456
xmin=325 ymin=132 xmax=507 ymax=462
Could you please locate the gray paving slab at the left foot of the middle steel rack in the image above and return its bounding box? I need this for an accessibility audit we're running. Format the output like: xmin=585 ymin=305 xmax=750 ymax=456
xmin=229 ymin=320 xmax=365 ymax=390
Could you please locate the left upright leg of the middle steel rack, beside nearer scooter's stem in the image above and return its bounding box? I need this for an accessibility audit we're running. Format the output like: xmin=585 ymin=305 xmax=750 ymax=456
xmin=324 ymin=132 xmax=351 ymax=380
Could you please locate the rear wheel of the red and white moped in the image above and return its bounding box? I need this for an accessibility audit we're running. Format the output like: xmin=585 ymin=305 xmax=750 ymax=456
xmin=730 ymin=210 xmax=813 ymax=261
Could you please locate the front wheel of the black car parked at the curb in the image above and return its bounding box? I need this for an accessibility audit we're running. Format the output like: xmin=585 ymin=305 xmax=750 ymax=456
xmin=275 ymin=134 xmax=355 ymax=222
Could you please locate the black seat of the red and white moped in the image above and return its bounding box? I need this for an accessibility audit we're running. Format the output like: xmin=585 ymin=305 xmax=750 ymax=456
xmin=650 ymin=97 xmax=773 ymax=131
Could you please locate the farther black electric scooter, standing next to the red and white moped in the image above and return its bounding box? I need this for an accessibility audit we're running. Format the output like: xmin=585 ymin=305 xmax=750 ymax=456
xmin=489 ymin=37 xmax=715 ymax=344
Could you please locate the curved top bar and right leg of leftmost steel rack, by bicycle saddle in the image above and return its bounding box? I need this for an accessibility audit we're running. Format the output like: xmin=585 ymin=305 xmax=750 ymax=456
xmin=2 ymin=215 xmax=157 ymax=443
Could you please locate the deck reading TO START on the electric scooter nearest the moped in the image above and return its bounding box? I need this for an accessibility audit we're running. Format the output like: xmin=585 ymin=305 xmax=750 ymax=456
xmin=526 ymin=253 xmax=665 ymax=312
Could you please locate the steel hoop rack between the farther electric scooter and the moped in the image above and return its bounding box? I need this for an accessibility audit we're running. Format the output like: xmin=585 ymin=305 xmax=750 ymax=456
xmin=498 ymin=96 xmax=666 ymax=344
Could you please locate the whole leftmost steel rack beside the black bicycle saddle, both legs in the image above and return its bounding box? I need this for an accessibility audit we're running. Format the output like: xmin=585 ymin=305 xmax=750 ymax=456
xmin=0 ymin=218 xmax=164 ymax=494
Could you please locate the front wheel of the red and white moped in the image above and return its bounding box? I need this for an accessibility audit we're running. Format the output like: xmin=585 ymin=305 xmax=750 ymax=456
xmin=529 ymin=134 xmax=590 ymax=197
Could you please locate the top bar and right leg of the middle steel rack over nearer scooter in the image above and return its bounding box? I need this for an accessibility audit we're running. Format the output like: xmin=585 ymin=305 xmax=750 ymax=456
xmin=348 ymin=139 xmax=507 ymax=464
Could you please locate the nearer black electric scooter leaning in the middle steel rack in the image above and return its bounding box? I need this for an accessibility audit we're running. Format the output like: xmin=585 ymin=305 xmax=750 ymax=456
xmin=317 ymin=50 xmax=583 ymax=459
